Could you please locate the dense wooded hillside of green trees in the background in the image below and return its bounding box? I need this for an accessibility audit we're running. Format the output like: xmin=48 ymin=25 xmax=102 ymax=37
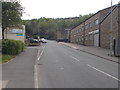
xmin=25 ymin=14 xmax=92 ymax=39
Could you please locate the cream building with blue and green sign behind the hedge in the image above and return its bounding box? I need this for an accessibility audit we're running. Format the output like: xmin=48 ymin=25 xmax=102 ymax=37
xmin=4 ymin=25 xmax=25 ymax=42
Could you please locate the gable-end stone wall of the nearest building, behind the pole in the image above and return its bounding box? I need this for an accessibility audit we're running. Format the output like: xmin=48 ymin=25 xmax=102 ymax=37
xmin=100 ymin=8 xmax=118 ymax=49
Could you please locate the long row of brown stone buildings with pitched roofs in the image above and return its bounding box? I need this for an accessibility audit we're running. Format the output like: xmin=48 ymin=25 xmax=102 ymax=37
xmin=71 ymin=4 xmax=120 ymax=49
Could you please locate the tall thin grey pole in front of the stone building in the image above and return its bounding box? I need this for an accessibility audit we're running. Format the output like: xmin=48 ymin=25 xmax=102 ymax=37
xmin=109 ymin=0 xmax=113 ymax=56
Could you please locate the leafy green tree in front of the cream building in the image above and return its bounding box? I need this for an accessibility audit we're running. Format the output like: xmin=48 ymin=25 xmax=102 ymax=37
xmin=2 ymin=2 xmax=23 ymax=39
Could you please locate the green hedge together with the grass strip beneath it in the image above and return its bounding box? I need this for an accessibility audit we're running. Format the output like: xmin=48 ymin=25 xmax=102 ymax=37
xmin=0 ymin=39 xmax=25 ymax=63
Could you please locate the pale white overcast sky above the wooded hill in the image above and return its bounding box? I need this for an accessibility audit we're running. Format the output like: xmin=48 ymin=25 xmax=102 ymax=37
xmin=20 ymin=0 xmax=120 ymax=19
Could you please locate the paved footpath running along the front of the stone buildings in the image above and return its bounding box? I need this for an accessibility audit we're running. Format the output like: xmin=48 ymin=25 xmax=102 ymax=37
xmin=60 ymin=42 xmax=120 ymax=63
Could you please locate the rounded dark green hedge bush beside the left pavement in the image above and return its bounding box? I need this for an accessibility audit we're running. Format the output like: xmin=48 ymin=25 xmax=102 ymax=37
xmin=2 ymin=39 xmax=25 ymax=55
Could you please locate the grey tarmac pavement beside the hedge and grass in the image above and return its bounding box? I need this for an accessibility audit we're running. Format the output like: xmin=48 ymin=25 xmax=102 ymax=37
xmin=2 ymin=48 xmax=37 ymax=90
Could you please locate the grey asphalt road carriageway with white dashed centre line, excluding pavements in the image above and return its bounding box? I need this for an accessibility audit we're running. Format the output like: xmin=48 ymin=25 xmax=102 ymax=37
xmin=36 ymin=41 xmax=118 ymax=88
